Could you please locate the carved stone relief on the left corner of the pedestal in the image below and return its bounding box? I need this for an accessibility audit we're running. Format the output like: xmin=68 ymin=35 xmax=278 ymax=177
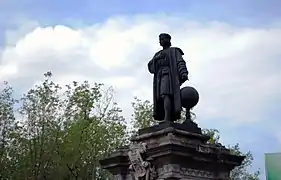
xmin=128 ymin=143 xmax=157 ymax=180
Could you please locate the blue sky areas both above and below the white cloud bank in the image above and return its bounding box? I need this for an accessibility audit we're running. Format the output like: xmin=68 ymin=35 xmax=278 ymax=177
xmin=0 ymin=0 xmax=281 ymax=179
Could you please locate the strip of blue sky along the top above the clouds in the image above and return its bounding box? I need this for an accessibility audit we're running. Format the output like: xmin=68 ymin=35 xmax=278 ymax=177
xmin=0 ymin=0 xmax=281 ymax=25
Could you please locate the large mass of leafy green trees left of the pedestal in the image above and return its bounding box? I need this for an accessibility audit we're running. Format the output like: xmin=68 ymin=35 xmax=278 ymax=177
xmin=0 ymin=72 xmax=127 ymax=180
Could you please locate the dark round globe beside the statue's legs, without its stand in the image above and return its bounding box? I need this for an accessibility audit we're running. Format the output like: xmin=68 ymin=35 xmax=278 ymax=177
xmin=181 ymin=86 xmax=199 ymax=110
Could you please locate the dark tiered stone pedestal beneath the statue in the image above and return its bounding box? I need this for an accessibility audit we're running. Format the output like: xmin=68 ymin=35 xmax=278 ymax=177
xmin=100 ymin=121 xmax=245 ymax=180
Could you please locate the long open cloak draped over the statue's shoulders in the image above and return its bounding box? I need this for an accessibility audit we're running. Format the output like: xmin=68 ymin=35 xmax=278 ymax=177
xmin=148 ymin=47 xmax=188 ymax=121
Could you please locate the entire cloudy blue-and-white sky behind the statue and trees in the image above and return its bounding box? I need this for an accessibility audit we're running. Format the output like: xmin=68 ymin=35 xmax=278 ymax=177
xmin=0 ymin=0 xmax=281 ymax=178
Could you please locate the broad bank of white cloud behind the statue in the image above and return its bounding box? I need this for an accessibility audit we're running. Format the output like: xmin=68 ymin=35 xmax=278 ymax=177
xmin=0 ymin=16 xmax=281 ymax=127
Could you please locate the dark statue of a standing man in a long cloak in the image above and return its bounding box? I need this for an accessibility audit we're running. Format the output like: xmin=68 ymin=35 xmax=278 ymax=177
xmin=148 ymin=33 xmax=188 ymax=122
